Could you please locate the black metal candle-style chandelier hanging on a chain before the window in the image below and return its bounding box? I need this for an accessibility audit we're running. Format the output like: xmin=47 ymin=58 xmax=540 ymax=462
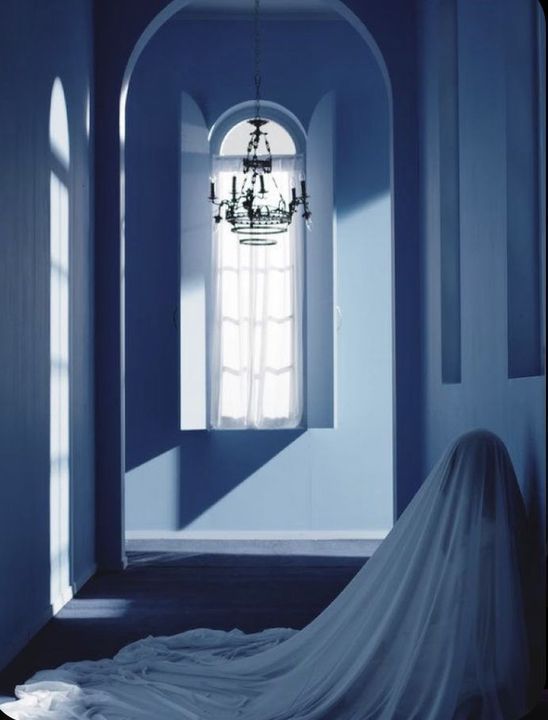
xmin=209 ymin=0 xmax=311 ymax=245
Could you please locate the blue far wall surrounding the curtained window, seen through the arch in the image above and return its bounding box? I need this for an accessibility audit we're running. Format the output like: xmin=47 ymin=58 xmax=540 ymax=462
xmin=125 ymin=12 xmax=393 ymax=532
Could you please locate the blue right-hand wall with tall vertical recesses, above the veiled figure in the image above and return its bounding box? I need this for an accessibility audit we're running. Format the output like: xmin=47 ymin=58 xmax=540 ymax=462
xmin=421 ymin=0 xmax=546 ymax=533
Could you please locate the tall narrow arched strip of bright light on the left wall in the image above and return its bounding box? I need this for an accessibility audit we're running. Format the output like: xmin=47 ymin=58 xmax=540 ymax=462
xmin=49 ymin=78 xmax=71 ymax=612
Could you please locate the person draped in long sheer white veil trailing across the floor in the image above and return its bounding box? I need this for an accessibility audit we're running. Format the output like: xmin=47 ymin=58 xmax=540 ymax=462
xmin=2 ymin=431 xmax=543 ymax=720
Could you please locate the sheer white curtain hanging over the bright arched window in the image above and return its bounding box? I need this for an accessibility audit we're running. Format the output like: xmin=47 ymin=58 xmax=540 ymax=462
xmin=210 ymin=157 xmax=303 ymax=429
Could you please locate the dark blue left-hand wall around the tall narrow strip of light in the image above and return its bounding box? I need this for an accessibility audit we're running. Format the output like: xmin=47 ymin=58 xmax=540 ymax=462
xmin=0 ymin=0 xmax=95 ymax=666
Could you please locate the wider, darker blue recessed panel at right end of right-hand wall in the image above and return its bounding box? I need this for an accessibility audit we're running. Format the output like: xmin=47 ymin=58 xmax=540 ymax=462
xmin=505 ymin=2 xmax=542 ymax=378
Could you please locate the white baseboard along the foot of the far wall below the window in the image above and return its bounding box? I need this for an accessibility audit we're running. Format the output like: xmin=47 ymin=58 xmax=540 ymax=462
xmin=126 ymin=529 xmax=390 ymax=541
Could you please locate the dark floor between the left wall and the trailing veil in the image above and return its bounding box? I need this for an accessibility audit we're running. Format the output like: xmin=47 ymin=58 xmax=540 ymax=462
xmin=0 ymin=553 xmax=548 ymax=720
